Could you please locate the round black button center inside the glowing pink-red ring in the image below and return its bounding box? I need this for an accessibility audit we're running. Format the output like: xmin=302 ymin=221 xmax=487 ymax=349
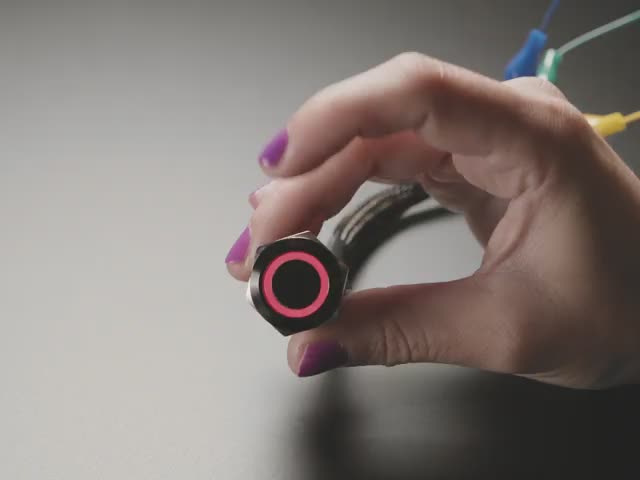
xmin=273 ymin=260 xmax=320 ymax=309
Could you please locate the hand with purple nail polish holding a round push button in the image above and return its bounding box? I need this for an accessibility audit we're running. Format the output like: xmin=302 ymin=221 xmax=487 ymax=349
xmin=228 ymin=53 xmax=640 ymax=388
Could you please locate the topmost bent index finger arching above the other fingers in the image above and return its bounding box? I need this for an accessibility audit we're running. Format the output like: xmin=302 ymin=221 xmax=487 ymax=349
xmin=263 ymin=54 xmax=588 ymax=198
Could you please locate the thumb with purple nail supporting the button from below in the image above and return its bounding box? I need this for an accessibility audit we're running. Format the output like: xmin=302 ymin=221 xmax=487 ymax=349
xmin=288 ymin=274 xmax=521 ymax=377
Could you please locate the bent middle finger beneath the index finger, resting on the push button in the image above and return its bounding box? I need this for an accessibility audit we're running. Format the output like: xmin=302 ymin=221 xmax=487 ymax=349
xmin=227 ymin=132 xmax=443 ymax=280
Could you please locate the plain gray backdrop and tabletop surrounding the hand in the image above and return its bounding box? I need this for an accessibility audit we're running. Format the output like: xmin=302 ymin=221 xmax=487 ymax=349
xmin=0 ymin=0 xmax=640 ymax=480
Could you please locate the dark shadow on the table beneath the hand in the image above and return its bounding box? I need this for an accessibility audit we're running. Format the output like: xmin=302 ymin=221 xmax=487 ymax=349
xmin=297 ymin=371 xmax=640 ymax=480
